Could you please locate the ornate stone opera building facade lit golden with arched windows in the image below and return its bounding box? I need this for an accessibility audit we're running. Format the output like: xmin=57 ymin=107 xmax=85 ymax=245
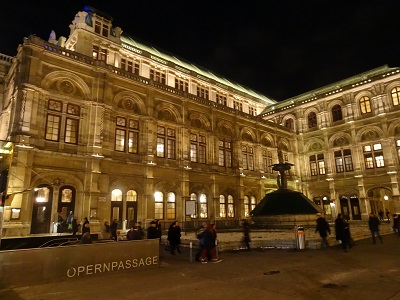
xmin=0 ymin=10 xmax=400 ymax=236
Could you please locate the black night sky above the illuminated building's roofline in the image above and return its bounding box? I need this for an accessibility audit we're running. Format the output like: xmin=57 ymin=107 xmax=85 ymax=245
xmin=0 ymin=0 xmax=400 ymax=101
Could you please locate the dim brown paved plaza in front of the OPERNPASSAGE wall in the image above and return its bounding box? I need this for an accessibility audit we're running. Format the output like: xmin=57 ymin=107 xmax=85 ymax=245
xmin=0 ymin=227 xmax=400 ymax=300
